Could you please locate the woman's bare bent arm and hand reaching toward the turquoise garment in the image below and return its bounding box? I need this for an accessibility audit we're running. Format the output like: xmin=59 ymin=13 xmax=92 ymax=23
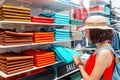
xmin=73 ymin=50 xmax=112 ymax=80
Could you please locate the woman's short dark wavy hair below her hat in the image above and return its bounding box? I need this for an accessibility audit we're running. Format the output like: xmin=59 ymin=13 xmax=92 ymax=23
xmin=89 ymin=29 xmax=114 ymax=44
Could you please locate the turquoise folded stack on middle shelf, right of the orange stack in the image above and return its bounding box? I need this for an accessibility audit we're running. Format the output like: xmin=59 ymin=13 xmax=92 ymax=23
xmin=54 ymin=29 xmax=70 ymax=41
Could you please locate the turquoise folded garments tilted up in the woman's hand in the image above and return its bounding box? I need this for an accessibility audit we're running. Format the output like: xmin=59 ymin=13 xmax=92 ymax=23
xmin=49 ymin=45 xmax=81 ymax=63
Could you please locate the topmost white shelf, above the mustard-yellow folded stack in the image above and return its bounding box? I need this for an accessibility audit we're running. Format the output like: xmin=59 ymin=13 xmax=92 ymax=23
xmin=1 ymin=0 xmax=80 ymax=12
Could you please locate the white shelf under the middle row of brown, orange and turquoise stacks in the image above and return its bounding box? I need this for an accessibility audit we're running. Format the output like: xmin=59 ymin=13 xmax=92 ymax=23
xmin=0 ymin=40 xmax=73 ymax=49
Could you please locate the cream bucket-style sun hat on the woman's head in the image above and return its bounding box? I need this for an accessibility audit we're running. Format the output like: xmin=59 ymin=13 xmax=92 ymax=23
xmin=81 ymin=15 xmax=113 ymax=30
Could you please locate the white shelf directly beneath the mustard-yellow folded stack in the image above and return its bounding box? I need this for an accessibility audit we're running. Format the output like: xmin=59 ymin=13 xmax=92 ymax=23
xmin=0 ymin=21 xmax=80 ymax=26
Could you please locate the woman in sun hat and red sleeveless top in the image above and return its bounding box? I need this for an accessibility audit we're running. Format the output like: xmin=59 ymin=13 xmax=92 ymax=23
xmin=73 ymin=16 xmax=114 ymax=80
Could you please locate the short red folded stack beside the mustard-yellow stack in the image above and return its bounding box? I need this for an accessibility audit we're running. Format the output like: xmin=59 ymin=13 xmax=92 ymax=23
xmin=31 ymin=16 xmax=54 ymax=24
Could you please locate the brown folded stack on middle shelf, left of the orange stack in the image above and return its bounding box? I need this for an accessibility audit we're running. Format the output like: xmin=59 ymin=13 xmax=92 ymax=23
xmin=0 ymin=29 xmax=33 ymax=46
